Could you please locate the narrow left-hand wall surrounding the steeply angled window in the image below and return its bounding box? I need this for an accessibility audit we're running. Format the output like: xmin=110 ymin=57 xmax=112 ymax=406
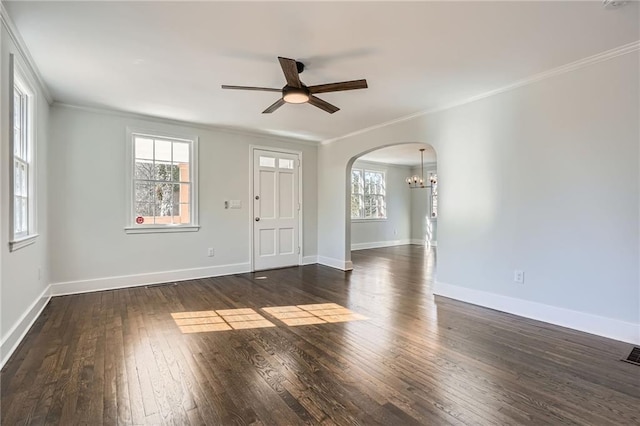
xmin=0 ymin=22 xmax=49 ymax=365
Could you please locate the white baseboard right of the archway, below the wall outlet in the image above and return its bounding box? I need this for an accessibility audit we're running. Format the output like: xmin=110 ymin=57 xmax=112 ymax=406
xmin=433 ymin=281 xmax=640 ymax=344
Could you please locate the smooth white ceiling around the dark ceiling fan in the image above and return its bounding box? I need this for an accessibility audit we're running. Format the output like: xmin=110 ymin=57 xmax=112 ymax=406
xmin=3 ymin=1 xmax=640 ymax=141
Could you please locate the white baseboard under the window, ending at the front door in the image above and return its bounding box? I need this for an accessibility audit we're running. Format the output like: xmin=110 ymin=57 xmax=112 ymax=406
xmin=51 ymin=262 xmax=251 ymax=296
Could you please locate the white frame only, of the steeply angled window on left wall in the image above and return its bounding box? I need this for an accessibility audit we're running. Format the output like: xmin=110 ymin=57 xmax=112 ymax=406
xmin=9 ymin=54 xmax=38 ymax=252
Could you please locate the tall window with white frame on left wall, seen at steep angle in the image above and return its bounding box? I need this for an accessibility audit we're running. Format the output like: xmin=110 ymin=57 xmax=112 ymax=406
xmin=10 ymin=55 xmax=37 ymax=251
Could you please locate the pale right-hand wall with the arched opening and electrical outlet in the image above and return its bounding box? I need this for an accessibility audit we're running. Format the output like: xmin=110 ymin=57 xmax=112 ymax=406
xmin=318 ymin=51 xmax=640 ymax=343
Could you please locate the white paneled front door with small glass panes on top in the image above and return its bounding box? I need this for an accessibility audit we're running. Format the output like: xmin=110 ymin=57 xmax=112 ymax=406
xmin=253 ymin=149 xmax=300 ymax=270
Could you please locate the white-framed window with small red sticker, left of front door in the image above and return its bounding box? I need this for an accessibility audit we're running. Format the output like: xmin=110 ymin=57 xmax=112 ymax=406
xmin=126 ymin=132 xmax=198 ymax=233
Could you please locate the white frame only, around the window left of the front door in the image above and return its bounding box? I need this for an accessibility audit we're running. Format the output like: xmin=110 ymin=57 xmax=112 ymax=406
xmin=124 ymin=127 xmax=200 ymax=234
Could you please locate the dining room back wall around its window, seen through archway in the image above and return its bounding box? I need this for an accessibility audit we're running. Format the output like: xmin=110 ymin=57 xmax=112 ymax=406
xmin=351 ymin=161 xmax=411 ymax=250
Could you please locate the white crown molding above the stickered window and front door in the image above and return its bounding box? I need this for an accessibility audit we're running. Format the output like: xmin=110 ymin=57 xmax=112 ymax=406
xmin=52 ymin=101 xmax=320 ymax=146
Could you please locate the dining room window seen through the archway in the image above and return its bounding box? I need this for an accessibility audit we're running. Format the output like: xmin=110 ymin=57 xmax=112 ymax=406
xmin=351 ymin=169 xmax=387 ymax=219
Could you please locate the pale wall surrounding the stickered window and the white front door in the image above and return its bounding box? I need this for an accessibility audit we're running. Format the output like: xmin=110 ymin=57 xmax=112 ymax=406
xmin=50 ymin=105 xmax=317 ymax=294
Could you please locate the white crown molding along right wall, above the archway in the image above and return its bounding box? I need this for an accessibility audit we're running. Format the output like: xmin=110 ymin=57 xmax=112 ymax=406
xmin=320 ymin=40 xmax=640 ymax=145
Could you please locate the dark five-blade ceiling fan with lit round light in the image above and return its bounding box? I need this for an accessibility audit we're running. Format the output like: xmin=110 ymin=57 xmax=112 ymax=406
xmin=222 ymin=57 xmax=368 ymax=114
